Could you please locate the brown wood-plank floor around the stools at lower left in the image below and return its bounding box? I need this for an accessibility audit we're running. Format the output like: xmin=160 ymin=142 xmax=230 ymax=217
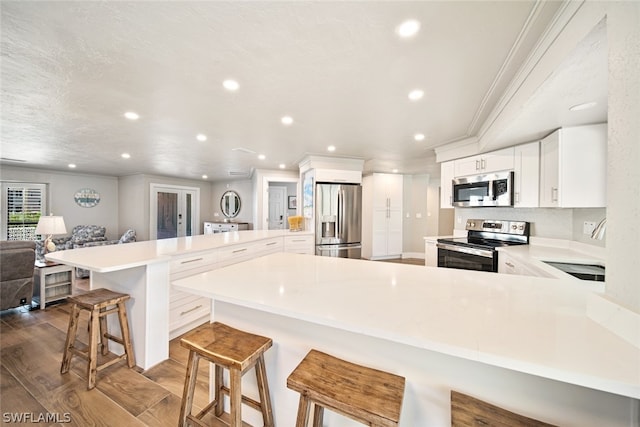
xmin=0 ymin=303 xmax=214 ymax=427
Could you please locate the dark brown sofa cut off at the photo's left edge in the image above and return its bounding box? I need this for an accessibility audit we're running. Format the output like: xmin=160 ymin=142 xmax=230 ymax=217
xmin=0 ymin=240 xmax=36 ymax=310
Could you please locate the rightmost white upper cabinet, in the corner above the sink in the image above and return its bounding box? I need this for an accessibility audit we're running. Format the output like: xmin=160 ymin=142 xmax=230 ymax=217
xmin=540 ymin=124 xmax=607 ymax=208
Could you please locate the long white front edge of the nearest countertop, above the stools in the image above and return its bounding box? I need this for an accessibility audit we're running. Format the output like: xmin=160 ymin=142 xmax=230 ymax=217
xmin=172 ymin=284 xmax=640 ymax=399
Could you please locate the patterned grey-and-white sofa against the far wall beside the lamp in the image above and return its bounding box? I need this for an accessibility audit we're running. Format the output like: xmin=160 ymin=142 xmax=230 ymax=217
xmin=36 ymin=225 xmax=136 ymax=278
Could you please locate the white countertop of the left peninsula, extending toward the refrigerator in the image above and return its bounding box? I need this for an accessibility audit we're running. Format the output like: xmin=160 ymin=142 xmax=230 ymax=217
xmin=46 ymin=230 xmax=313 ymax=273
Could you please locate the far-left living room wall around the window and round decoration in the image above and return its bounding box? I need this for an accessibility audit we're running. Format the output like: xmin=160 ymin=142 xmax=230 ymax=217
xmin=0 ymin=165 xmax=120 ymax=239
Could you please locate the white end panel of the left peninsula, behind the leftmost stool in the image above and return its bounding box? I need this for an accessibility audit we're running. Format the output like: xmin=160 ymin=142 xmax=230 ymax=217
xmin=90 ymin=262 xmax=169 ymax=370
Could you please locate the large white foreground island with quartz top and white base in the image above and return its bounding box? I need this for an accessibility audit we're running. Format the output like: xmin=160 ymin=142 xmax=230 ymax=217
xmin=173 ymin=253 xmax=640 ymax=427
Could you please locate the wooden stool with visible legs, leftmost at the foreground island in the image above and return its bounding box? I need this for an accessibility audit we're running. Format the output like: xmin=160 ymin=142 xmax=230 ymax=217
xmin=179 ymin=322 xmax=273 ymax=427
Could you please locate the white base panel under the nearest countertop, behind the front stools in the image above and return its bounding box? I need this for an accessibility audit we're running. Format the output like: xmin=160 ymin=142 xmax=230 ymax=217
xmin=214 ymin=301 xmax=637 ymax=427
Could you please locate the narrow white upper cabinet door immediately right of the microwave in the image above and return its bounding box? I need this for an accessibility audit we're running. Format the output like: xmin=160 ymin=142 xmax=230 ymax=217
xmin=513 ymin=141 xmax=540 ymax=208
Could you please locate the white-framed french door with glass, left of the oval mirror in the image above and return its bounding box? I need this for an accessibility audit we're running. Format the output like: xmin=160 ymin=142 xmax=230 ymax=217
xmin=149 ymin=184 xmax=200 ymax=240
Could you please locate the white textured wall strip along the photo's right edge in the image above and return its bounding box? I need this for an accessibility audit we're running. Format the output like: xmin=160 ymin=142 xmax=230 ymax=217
xmin=606 ymin=1 xmax=640 ymax=315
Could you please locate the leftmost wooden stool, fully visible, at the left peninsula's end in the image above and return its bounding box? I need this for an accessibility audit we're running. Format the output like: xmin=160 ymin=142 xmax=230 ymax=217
xmin=60 ymin=288 xmax=136 ymax=390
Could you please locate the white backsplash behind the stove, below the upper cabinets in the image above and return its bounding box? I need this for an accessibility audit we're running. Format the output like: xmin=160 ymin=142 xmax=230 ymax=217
xmin=454 ymin=208 xmax=607 ymax=247
